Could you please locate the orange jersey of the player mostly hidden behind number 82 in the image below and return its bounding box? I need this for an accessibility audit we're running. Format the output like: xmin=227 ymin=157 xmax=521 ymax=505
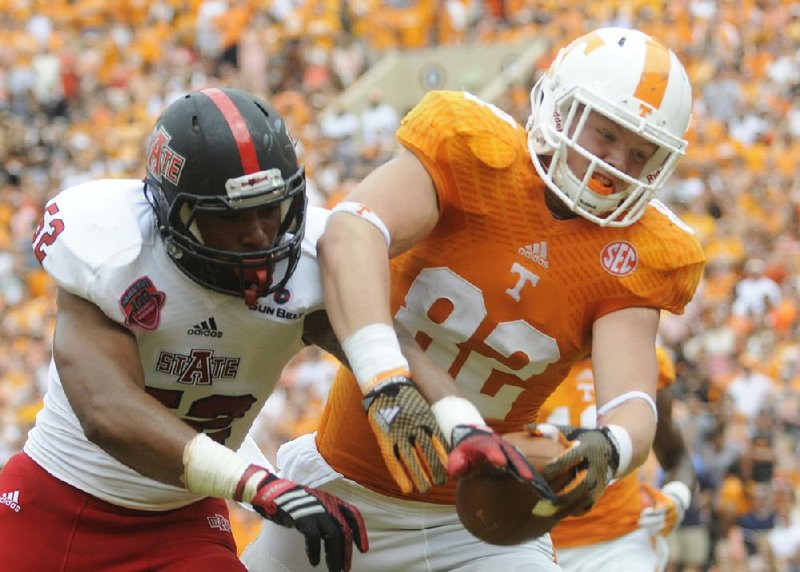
xmin=539 ymin=348 xmax=675 ymax=548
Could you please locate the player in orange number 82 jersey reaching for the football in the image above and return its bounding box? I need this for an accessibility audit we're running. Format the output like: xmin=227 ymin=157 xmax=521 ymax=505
xmin=243 ymin=28 xmax=705 ymax=571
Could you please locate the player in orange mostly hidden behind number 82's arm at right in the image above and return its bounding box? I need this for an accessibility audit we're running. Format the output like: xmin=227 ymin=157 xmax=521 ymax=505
xmin=539 ymin=348 xmax=695 ymax=572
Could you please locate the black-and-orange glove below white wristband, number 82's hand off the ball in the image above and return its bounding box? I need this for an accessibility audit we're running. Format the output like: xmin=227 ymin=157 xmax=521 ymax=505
xmin=363 ymin=375 xmax=447 ymax=494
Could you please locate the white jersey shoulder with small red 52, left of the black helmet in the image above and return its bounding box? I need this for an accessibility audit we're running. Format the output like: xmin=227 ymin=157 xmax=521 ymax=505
xmin=33 ymin=180 xmax=152 ymax=299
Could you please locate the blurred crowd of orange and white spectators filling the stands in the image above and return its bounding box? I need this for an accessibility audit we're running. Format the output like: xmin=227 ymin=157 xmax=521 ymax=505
xmin=0 ymin=0 xmax=800 ymax=572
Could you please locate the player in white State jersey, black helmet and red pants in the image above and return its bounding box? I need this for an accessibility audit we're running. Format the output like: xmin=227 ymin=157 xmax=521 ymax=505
xmin=0 ymin=88 xmax=376 ymax=572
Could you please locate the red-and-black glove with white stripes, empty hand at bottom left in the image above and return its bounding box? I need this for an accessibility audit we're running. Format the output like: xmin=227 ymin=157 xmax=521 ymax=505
xmin=251 ymin=466 xmax=369 ymax=572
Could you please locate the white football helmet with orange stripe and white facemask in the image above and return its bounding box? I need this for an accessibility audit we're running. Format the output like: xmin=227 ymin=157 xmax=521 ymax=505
xmin=527 ymin=28 xmax=692 ymax=226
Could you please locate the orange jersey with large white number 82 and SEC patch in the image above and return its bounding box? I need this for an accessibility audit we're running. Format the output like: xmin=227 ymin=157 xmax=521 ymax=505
xmin=317 ymin=92 xmax=705 ymax=503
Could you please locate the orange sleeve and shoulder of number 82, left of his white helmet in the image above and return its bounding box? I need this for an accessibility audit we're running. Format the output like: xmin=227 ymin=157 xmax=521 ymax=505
xmin=397 ymin=91 xmax=527 ymax=218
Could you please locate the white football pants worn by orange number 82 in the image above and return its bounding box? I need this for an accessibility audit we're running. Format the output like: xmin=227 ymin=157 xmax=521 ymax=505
xmin=242 ymin=435 xmax=560 ymax=572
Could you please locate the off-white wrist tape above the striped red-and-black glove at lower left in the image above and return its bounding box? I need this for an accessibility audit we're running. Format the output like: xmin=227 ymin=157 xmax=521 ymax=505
xmin=183 ymin=433 xmax=267 ymax=502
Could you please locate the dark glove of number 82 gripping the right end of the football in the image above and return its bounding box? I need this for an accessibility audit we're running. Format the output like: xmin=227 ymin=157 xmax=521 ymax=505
xmin=542 ymin=427 xmax=619 ymax=515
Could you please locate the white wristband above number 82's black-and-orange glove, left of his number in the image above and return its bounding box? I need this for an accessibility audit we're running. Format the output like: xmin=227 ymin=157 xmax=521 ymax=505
xmin=342 ymin=324 xmax=410 ymax=393
